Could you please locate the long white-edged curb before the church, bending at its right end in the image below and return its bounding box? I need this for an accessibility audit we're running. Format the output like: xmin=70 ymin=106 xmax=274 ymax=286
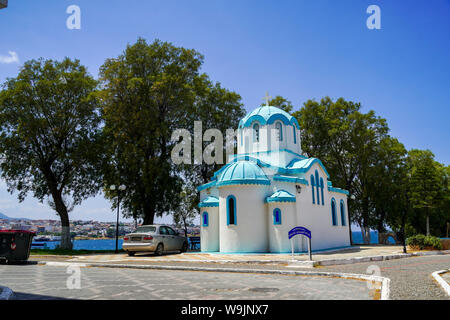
xmin=38 ymin=261 xmax=391 ymax=300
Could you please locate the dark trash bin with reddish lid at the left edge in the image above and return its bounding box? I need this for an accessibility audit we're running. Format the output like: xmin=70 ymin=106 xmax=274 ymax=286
xmin=0 ymin=230 xmax=36 ymax=262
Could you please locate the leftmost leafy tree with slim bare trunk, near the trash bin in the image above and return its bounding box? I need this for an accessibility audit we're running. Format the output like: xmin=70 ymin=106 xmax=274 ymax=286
xmin=0 ymin=58 xmax=102 ymax=249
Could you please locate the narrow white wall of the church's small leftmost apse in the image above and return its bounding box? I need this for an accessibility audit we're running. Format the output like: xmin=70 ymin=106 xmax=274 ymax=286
xmin=200 ymin=207 xmax=220 ymax=252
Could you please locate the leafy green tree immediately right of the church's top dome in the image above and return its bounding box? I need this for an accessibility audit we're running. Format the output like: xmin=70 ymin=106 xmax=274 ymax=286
xmin=293 ymin=97 xmax=389 ymax=242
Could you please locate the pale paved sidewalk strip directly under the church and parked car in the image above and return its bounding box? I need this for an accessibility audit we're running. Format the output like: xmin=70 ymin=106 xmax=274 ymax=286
xmin=30 ymin=246 xmax=403 ymax=264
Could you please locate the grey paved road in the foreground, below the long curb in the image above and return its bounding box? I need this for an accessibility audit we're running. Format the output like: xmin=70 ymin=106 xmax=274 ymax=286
xmin=0 ymin=265 xmax=373 ymax=300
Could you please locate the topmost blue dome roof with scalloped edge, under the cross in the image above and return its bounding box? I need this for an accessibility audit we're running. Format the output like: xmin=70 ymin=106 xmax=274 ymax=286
xmin=239 ymin=106 xmax=300 ymax=129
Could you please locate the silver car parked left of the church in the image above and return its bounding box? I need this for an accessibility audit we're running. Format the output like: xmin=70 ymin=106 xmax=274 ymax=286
xmin=122 ymin=225 xmax=188 ymax=256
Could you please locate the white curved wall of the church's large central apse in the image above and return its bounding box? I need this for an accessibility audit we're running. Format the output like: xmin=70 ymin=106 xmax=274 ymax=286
xmin=219 ymin=185 xmax=270 ymax=252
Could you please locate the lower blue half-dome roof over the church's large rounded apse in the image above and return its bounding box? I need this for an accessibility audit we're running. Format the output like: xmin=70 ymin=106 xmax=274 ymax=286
xmin=216 ymin=161 xmax=270 ymax=186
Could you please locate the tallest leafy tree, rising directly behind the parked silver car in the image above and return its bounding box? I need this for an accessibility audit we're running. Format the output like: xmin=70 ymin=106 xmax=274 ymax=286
xmin=100 ymin=39 xmax=203 ymax=224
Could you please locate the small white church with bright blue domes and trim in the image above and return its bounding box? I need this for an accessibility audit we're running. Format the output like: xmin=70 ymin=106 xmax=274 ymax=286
xmin=198 ymin=99 xmax=350 ymax=253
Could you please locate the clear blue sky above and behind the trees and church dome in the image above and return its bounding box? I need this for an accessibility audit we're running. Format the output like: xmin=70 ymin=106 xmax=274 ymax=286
xmin=0 ymin=0 xmax=450 ymax=221
